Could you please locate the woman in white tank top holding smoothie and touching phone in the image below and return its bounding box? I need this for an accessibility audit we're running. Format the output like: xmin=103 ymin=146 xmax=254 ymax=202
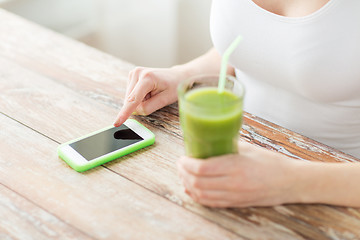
xmin=115 ymin=0 xmax=360 ymax=207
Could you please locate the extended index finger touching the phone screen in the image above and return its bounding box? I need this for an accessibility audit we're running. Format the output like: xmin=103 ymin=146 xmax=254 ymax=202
xmin=114 ymin=78 xmax=154 ymax=127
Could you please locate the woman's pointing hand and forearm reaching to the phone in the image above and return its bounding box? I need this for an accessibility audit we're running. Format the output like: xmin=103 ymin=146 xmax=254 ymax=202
xmin=114 ymin=48 xmax=235 ymax=127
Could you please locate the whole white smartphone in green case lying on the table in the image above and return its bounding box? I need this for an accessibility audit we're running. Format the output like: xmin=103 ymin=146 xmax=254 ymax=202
xmin=58 ymin=119 xmax=155 ymax=172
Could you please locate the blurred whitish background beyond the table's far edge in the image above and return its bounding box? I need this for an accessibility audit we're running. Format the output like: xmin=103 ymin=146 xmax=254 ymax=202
xmin=0 ymin=0 xmax=211 ymax=67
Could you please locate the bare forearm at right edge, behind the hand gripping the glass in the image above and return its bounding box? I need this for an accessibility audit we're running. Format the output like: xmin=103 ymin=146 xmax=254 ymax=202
xmin=294 ymin=162 xmax=360 ymax=207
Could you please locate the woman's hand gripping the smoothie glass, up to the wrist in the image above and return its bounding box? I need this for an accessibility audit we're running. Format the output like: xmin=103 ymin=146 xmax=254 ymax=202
xmin=177 ymin=142 xmax=301 ymax=207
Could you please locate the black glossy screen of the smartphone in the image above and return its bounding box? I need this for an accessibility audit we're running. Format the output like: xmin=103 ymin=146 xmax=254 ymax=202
xmin=70 ymin=125 xmax=143 ymax=161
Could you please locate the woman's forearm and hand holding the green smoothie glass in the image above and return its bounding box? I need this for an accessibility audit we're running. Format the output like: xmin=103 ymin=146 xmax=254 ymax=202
xmin=178 ymin=142 xmax=360 ymax=207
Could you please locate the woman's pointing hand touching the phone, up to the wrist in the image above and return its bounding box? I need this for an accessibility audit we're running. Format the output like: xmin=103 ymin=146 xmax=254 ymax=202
xmin=114 ymin=67 xmax=187 ymax=127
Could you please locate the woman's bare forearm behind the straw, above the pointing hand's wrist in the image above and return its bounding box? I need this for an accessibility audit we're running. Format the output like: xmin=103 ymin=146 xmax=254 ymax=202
xmin=174 ymin=48 xmax=235 ymax=77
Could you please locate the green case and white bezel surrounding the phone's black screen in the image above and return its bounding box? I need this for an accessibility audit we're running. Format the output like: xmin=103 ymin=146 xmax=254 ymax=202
xmin=57 ymin=119 xmax=155 ymax=172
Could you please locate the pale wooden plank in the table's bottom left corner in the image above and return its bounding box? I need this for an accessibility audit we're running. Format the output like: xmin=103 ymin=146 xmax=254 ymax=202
xmin=0 ymin=184 xmax=92 ymax=240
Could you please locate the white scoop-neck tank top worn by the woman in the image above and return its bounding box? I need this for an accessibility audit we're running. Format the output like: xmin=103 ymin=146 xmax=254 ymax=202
xmin=210 ymin=0 xmax=360 ymax=158
